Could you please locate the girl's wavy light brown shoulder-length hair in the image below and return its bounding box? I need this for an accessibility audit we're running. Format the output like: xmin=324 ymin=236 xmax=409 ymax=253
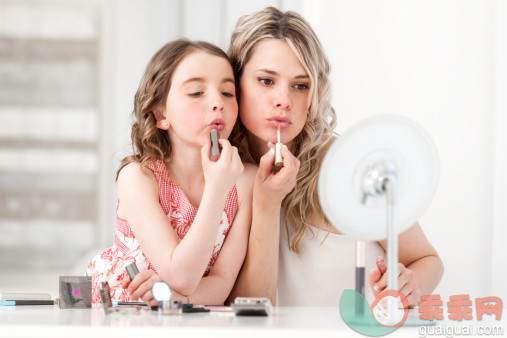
xmin=116 ymin=39 xmax=232 ymax=180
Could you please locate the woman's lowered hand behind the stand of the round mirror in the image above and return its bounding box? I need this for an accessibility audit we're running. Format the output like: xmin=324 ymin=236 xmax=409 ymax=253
xmin=368 ymin=257 xmax=421 ymax=308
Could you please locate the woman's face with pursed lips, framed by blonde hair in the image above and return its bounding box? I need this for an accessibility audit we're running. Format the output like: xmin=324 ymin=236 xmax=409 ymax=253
xmin=239 ymin=39 xmax=311 ymax=152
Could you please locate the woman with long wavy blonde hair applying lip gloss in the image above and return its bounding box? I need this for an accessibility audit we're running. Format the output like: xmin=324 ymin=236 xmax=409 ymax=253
xmin=229 ymin=7 xmax=443 ymax=307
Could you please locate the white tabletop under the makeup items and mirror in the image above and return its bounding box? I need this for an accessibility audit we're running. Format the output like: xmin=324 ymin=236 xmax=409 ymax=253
xmin=0 ymin=306 xmax=504 ymax=338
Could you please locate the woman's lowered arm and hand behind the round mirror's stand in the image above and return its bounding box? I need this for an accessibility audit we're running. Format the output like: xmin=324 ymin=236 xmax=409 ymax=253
xmin=369 ymin=223 xmax=444 ymax=307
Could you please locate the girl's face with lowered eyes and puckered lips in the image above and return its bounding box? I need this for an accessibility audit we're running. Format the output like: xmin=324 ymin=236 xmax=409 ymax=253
xmin=161 ymin=51 xmax=238 ymax=148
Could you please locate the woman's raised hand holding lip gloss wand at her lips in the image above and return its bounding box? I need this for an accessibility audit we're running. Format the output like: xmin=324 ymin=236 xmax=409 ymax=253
xmin=254 ymin=142 xmax=301 ymax=208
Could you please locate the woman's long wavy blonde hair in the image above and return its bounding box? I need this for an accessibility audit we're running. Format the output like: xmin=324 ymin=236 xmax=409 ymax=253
xmin=228 ymin=7 xmax=336 ymax=255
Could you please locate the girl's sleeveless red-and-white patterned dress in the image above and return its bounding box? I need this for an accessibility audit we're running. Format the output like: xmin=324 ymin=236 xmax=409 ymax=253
xmin=86 ymin=160 xmax=238 ymax=303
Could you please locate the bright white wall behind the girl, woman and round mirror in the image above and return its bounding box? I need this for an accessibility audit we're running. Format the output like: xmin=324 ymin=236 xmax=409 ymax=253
xmin=107 ymin=0 xmax=507 ymax=299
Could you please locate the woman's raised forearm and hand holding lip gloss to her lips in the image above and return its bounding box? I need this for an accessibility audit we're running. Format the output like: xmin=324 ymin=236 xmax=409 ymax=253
xmin=228 ymin=148 xmax=300 ymax=304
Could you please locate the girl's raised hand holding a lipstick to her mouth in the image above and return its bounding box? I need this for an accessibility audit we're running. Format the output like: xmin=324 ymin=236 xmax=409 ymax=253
xmin=201 ymin=139 xmax=244 ymax=194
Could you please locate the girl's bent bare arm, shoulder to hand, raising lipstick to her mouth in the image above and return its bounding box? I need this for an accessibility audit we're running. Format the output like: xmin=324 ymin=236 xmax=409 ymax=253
xmin=118 ymin=140 xmax=243 ymax=295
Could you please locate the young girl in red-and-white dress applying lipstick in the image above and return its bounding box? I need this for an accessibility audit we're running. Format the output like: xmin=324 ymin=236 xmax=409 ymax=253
xmin=86 ymin=40 xmax=256 ymax=305
